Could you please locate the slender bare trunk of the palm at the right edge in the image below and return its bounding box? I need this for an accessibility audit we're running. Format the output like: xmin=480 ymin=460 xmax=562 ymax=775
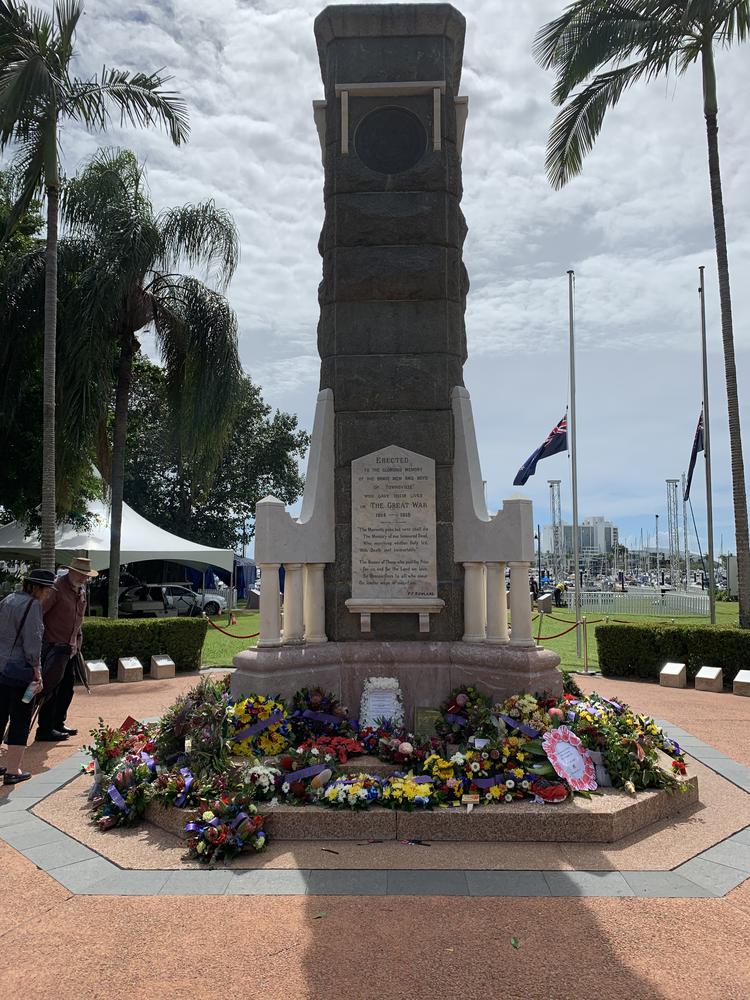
xmin=702 ymin=44 xmax=750 ymax=628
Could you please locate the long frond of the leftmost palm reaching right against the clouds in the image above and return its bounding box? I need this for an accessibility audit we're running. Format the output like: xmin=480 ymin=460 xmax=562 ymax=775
xmin=62 ymin=67 xmax=190 ymax=146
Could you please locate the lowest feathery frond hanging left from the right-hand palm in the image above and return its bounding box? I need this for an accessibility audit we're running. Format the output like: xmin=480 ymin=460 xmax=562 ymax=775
xmin=545 ymin=60 xmax=650 ymax=188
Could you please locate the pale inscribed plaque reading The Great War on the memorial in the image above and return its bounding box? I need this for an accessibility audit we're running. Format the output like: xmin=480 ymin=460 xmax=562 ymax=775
xmin=352 ymin=445 xmax=437 ymax=599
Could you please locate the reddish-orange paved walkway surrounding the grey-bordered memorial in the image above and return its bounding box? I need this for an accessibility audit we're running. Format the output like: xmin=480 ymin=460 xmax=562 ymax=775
xmin=0 ymin=678 xmax=750 ymax=1000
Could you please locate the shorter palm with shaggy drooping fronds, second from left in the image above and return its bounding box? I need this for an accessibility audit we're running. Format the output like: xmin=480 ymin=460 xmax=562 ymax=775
xmin=63 ymin=150 xmax=242 ymax=617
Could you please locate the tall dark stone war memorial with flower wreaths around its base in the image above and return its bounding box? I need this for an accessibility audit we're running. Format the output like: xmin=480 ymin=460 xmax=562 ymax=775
xmin=35 ymin=4 xmax=704 ymax=869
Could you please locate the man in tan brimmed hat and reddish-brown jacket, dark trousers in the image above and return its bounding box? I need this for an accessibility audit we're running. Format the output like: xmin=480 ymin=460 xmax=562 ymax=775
xmin=36 ymin=556 xmax=99 ymax=743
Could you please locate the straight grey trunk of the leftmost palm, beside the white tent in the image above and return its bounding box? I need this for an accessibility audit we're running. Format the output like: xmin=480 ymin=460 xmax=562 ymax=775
xmin=41 ymin=180 xmax=58 ymax=572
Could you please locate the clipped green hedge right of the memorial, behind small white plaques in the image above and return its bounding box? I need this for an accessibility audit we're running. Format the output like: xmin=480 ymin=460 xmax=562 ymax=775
xmin=595 ymin=624 xmax=750 ymax=688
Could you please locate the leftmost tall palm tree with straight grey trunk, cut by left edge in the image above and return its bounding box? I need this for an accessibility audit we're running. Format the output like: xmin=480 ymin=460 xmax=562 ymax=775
xmin=0 ymin=0 xmax=189 ymax=569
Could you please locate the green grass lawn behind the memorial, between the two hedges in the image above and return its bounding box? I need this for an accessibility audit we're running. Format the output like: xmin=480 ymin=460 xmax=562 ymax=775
xmin=203 ymin=602 xmax=739 ymax=670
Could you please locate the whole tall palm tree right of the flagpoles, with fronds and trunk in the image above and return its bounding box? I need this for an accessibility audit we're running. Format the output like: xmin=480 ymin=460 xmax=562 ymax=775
xmin=534 ymin=0 xmax=750 ymax=628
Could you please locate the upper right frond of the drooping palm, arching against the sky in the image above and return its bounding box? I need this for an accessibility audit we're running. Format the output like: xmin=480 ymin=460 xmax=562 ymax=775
xmin=157 ymin=201 xmax=240 ymax=290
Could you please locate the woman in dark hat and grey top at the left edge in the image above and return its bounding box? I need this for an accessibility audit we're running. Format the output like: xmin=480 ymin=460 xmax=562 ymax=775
xmin=0 ymin=569 xmax=55 ymax=785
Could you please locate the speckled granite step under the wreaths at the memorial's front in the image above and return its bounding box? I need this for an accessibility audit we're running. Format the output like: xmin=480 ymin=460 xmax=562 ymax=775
xmin=146 ymin=776 xmax=698 ymax=844
